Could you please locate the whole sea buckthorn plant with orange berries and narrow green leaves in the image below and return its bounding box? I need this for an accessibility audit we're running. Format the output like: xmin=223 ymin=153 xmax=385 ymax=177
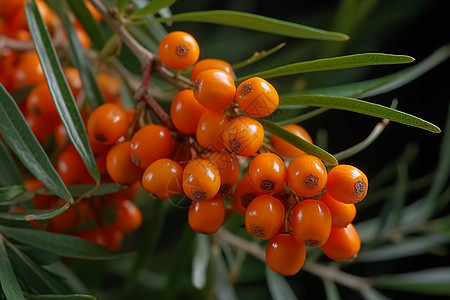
xmin=0 ymin=0 xmax=450 ymax=300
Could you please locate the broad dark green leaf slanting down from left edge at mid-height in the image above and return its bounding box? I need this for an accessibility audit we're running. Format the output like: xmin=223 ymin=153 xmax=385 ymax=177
xmin=0 ymin=85 xmax=73 ymax=202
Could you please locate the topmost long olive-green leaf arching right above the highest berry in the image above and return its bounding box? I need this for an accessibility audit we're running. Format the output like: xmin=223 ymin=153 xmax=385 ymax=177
xmin=144 ymin=10 xmax=349 ymax=41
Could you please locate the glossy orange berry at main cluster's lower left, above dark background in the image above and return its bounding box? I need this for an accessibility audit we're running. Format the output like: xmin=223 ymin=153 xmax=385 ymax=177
xmin=142 ymin=158 xmax=183 ymax=199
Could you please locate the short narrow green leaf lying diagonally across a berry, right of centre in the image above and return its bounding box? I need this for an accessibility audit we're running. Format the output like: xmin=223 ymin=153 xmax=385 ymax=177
xmin=262 ymin=119 xmax=338 ymax=165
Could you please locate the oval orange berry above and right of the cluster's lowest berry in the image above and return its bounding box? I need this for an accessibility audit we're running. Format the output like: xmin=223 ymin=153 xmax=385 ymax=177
xmin=291 ymin=199 xmax=331 ymax=247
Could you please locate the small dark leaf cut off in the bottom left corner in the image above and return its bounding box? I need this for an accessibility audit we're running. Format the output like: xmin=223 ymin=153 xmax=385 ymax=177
xmin=0 ymin=235 xmax=25 ymax=300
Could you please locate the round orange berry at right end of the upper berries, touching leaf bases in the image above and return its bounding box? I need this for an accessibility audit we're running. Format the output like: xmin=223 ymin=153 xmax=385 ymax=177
xmin=235 ymin=77 xmax=280 ymax=117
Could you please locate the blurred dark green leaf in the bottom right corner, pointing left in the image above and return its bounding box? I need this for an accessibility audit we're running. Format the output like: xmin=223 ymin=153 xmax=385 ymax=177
xmin=371 ymin=267 xmax=450 ymax=296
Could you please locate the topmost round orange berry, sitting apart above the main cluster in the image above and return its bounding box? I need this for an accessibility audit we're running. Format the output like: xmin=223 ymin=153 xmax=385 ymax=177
xmin=158 ymin=31 xmax=200 ymax=70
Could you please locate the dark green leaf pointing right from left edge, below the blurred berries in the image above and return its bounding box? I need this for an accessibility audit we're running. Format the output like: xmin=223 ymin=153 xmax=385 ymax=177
xmin=0 ymin=226 xmax=123 ymax=260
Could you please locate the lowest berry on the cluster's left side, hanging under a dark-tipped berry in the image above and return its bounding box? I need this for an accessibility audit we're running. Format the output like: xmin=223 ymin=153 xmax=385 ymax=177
xmin=188 ymin=195 xmax=225 ymax=234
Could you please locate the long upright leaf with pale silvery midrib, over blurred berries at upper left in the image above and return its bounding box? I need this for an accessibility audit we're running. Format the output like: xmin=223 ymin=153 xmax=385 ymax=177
xmin=25 ymin=1 xmax=100 ymax=182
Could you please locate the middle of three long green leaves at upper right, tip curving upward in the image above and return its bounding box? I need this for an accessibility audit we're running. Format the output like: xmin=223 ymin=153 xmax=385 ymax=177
xmin=236 ymin=53 xmax=414 ymax=82
